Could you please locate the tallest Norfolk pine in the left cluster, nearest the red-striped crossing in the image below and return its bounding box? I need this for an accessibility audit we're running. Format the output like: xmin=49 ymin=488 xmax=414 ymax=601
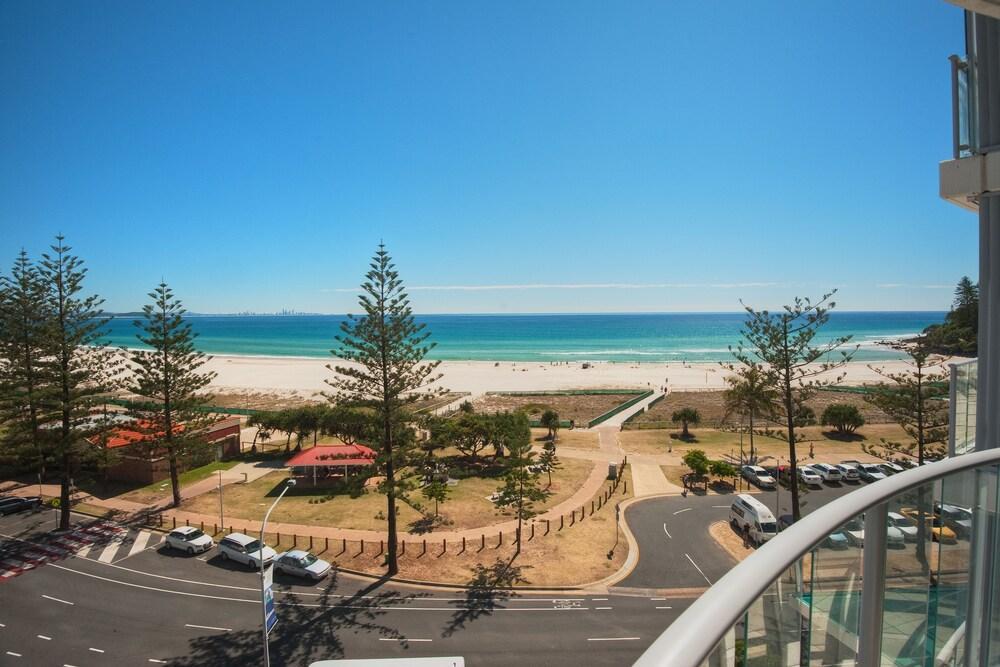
xmin=39 ymin=235 xmax=121 ymax=530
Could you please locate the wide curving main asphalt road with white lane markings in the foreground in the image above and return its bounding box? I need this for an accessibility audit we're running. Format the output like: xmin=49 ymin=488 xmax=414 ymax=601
xmin=0 ymin=511 xmax=690 ymax=667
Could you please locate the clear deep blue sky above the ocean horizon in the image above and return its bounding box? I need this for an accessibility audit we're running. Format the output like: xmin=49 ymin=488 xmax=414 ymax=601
xmin=0 ymin=0 xmax=977 ymax=313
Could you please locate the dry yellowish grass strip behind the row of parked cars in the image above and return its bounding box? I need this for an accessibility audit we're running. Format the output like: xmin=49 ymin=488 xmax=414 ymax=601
xmin=618 ymin=424 xmax=910 ymax=464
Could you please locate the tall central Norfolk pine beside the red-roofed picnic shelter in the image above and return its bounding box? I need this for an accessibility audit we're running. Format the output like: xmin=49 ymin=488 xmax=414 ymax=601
xmin=327 ymin=244 xmax=441 ymax=576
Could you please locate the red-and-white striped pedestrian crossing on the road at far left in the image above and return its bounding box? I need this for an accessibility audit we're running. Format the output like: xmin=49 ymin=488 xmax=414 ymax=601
xmin=0 ymin=521 xmax=163 ymax=582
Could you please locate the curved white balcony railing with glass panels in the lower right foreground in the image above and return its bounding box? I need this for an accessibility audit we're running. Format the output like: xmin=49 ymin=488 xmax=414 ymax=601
xmin=636 ymin=449 xmax=1000 ymax=667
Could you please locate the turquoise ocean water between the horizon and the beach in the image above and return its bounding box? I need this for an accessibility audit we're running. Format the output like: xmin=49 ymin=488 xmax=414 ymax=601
xmin=103 ymin=312 xmax=945 ymax=362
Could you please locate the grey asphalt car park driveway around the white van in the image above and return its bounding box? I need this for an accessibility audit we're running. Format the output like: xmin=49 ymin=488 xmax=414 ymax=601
xmin=618 ymin=483 xmax=863 ymax=591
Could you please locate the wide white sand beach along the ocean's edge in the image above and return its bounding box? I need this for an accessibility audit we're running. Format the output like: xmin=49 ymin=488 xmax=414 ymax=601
xmin=197 ymin=356 xmax=958 ymax=395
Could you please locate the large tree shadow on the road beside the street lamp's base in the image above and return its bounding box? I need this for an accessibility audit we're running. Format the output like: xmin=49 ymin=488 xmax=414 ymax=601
xmin=170 ymin=574 xmax=424 ymax=667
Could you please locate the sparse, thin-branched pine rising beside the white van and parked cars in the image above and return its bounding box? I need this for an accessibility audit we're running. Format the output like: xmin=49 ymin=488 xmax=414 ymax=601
xmin=729 ymin=290 xmax=857 ymax=521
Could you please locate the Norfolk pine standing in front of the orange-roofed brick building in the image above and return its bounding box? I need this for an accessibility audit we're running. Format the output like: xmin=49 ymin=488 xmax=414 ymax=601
xmin=131 ymin=282 xmax=215 ymax=507
